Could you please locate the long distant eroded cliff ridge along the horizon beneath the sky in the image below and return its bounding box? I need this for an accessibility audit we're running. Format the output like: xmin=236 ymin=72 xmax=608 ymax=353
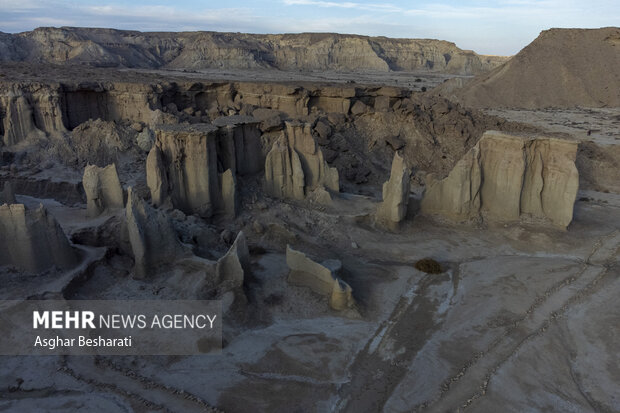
xmin=0 ymin=27 xmax=505 ymax=75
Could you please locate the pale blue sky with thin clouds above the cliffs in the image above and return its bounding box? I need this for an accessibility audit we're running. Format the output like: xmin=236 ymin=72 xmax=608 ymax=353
xmin=0 ymin=0 xmax=620 ymax=55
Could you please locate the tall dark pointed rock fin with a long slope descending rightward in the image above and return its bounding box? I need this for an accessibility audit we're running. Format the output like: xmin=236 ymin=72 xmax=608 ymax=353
xmin=125 ymin=187 xmax=184 ymax=279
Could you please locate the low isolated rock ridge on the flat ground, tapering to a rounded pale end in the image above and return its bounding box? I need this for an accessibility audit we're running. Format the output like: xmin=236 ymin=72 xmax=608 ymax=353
xmin=286 ymin=245 xmax=355 ymax=311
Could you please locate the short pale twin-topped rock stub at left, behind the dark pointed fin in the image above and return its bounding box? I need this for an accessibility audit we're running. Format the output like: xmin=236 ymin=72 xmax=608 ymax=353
xmin=82 ymin=164 xmax=125 ymax=217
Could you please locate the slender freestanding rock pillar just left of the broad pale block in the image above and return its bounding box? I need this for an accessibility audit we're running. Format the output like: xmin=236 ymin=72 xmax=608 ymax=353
xmin=377 ymin=152 xmax=411 ymax=225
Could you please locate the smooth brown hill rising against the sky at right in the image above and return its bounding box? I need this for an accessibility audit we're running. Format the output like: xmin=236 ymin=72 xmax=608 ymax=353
xmin=446 ymin=27 xmax=620 ymax=109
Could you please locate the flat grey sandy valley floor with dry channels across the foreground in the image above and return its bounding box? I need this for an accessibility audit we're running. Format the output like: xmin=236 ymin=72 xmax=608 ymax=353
xmin=0 ymin=183 xmax=620 ymax=412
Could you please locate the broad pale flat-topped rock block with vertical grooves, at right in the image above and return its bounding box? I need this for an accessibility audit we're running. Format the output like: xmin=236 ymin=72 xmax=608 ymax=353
xmin=421 ymin=131 xmax=579 ymax=228
